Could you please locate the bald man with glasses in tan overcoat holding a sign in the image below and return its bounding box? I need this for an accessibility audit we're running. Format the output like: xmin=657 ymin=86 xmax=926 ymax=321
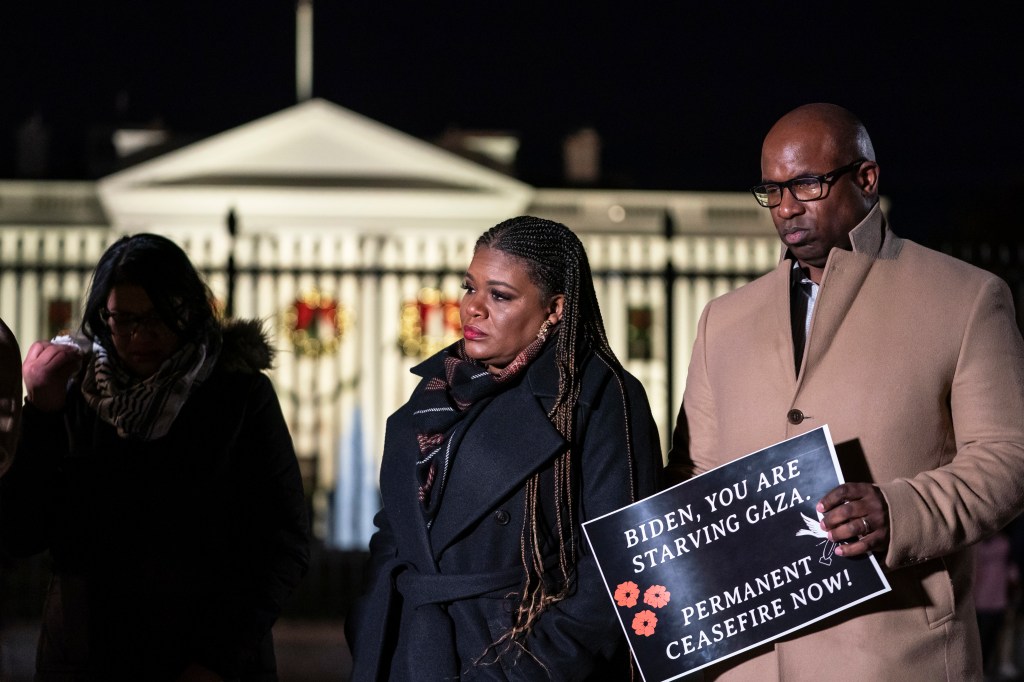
xmin=669 ymin=104 xmax=1024 ymax=682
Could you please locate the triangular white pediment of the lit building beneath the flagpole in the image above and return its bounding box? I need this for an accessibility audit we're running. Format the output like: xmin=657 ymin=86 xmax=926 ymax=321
xmin=98 ymin=99 xmax=534 ymax=231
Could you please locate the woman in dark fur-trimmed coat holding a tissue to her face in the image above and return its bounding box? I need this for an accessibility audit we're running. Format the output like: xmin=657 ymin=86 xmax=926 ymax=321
xmin=0 ymin=235 xmax=308 ymax=682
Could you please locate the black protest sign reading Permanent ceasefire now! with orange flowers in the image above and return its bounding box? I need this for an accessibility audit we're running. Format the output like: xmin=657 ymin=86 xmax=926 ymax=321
xmin=584 ymin=426 xmax=889 ymax=682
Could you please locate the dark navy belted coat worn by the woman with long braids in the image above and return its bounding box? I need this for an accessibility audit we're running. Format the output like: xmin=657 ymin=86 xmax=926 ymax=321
xmin=346 ymin=344 xmax=662 ymax=682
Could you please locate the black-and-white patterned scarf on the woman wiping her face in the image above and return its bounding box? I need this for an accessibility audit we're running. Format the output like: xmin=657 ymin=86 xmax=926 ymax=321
xmin=82 ymin=333 xmax=220 ymax=440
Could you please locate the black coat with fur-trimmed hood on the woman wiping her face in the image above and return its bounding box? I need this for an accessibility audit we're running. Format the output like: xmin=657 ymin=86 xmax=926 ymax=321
xmin=0 ymin=325 xmax=308 ymax=682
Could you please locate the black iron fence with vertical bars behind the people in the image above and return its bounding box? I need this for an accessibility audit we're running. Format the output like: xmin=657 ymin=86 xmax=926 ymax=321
xmin=0 ymin=229 xmax=1024 ymax=617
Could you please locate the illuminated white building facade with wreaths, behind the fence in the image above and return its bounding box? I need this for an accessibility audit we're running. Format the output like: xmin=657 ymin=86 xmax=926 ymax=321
xmin=0 ymin=99 xmax=778 ymax=547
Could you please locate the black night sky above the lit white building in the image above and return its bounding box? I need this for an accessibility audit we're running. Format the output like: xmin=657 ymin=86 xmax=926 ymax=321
xmin=0 ymin=0 xmax=1024 ymax=237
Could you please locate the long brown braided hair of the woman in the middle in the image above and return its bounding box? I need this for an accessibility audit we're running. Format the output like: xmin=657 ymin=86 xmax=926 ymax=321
xmin=474 ymin=216 xmax=632 ymax=645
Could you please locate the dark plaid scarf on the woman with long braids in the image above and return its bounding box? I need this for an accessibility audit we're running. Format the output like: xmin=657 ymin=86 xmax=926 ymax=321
xmin=412 ymin=329 xmax=555 ymax=528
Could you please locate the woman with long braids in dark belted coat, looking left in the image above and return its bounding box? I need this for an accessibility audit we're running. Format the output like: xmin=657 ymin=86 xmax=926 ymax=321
xmin=346 ymin=216 xmax=662 ymax=682
